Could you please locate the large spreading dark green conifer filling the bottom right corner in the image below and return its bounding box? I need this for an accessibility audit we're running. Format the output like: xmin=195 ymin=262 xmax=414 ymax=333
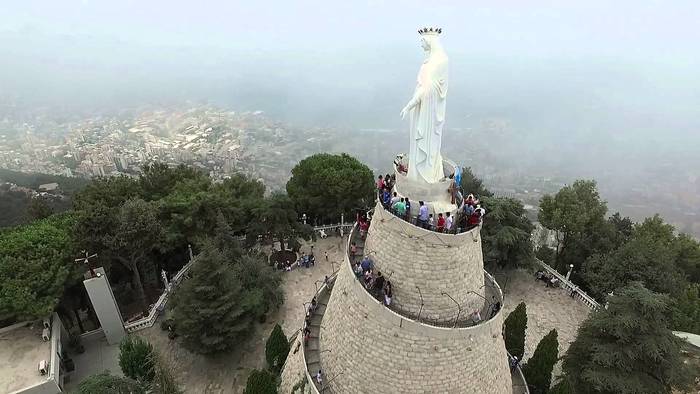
xmin=562 ymin=282 xmax=692 ymax=394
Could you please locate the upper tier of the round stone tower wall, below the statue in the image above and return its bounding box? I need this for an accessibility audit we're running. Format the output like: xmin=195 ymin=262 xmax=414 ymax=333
xmin=364 ymin=204 xmax=490 ymax=322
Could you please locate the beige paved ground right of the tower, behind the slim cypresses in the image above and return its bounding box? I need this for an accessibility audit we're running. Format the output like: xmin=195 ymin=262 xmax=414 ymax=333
xmin=494 ymin=270 xmax=590 ymax=376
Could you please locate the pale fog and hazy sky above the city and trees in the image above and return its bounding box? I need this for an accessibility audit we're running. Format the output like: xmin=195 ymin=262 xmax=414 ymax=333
xmin=0 ymin=0 xmax=700 ymax=234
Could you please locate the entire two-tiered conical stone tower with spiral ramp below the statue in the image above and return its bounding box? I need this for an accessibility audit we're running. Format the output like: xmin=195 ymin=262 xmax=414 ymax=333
xmin=280 ymin=159 xmax=527 ymax=394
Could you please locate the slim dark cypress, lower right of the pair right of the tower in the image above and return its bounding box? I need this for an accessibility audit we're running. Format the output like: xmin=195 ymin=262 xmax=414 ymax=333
xmin=523 ymin=330 xmax=559 ymax=394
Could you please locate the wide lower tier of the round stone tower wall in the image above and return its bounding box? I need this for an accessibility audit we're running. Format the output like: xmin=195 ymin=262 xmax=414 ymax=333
xmin=320 ymin=260 xmax=512 ymax=394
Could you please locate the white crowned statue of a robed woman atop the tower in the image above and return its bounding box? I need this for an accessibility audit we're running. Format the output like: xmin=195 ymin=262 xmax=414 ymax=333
xmin=401 ymin=28 xmax=447 ymax=183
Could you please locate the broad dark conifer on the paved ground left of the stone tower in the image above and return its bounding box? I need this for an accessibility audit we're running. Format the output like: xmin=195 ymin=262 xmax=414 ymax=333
xmin=174 ymin=244 xmax=263 ymax=354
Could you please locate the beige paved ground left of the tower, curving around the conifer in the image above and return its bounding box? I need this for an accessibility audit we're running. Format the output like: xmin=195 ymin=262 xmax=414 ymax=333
xmin=138 ymin=237 xmax=346 ymax=394
